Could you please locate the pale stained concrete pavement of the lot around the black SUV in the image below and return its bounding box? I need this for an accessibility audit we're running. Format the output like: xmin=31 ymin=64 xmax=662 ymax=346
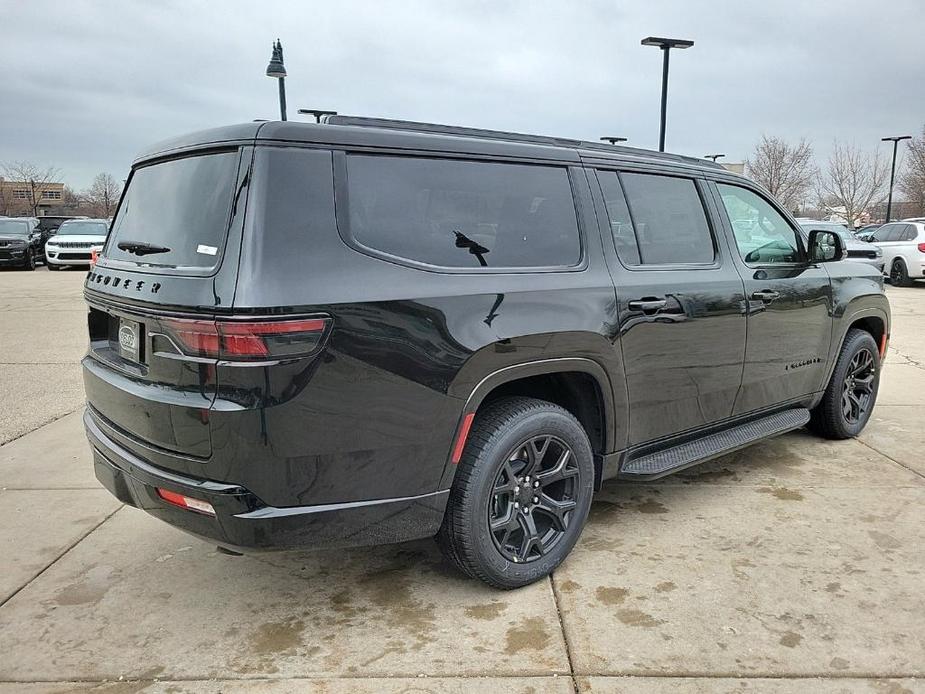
xmin=0 ymin=268 xmax=925 ymax=694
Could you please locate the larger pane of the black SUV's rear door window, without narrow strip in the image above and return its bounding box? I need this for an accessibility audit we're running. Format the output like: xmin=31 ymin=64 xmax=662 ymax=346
xmin=620 ymin=174 xmax=715 ymax=265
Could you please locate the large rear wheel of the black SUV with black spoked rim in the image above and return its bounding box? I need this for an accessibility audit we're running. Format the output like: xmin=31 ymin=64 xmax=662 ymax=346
xmin=437 ymin=397 xmax=594 ymax=590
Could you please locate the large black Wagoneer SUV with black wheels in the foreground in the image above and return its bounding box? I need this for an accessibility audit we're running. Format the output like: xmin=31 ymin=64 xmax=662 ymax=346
xmin=83 ymin=116 xmax=890 ymax=588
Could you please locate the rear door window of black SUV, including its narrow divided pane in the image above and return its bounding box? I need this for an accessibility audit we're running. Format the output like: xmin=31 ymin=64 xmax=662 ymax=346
xmin=598 ymin=171 xmax=716 ymax=265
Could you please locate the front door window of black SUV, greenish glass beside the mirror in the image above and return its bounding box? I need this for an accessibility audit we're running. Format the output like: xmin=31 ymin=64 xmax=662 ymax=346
xmin=717 ymin=183 xmax=800 ymax=263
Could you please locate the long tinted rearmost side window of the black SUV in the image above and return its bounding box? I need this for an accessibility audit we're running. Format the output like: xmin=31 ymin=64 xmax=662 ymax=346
xmin=347 ymin=155 xmax=581 ymax=268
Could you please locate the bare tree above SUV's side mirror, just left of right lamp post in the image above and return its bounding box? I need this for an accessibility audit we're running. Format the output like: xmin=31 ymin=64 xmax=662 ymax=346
xmin=817 ymin=140 xmax=888 ymax=227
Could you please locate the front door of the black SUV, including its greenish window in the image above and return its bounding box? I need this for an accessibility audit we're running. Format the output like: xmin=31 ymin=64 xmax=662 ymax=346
xmin=711 ymin=182 xmax=833 ymax=415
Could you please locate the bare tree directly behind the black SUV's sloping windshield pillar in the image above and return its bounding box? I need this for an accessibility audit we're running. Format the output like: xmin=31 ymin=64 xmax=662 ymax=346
xmin=745 ymin=135 xmax=816 ymax=209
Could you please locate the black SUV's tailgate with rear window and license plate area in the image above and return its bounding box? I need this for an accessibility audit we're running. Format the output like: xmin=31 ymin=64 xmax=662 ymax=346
xmin=83 ymin=146 xmax=253 ymax=464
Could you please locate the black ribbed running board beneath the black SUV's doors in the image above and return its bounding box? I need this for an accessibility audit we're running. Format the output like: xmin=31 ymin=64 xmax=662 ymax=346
xmin=618 ymin=407 xmax=809 ymax=480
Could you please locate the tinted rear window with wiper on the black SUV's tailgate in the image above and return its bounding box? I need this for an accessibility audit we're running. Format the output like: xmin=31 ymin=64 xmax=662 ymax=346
xmin=104 ymin=151 xmax=239 ymax=268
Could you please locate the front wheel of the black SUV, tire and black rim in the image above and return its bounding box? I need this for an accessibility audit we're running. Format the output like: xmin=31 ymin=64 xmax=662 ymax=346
xmin=808 ymin=328 xmax=880 ymax=439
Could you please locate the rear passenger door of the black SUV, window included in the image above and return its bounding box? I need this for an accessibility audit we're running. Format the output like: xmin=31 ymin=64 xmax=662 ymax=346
xmin=589 ymin=169 xmax=745 ymax=446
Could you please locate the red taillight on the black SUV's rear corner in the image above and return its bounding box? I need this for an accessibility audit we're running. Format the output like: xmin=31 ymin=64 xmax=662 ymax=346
xmin=163 ymin=318 xmax=330 ymax=361
